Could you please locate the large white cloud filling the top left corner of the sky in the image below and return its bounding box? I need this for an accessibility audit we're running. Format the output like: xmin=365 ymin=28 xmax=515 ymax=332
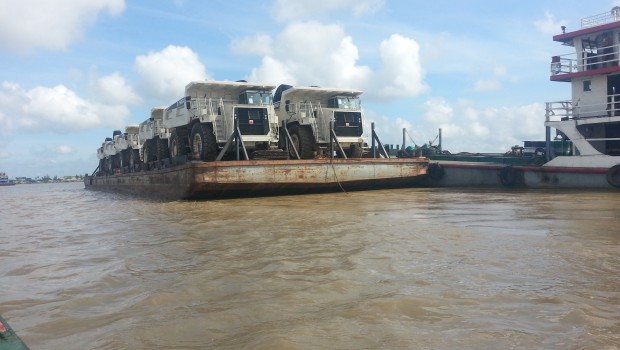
xmin=0 ymin=0 xmax=125 ymax=53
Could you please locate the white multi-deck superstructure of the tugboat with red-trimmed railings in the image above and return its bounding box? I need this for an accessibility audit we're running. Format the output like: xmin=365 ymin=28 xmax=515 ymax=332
xmin=545 ymin=7 xmax=620 ymax=168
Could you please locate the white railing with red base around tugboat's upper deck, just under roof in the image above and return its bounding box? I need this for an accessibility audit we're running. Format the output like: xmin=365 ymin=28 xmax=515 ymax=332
xmin=550 ymin=45 xmax=620 ymax=75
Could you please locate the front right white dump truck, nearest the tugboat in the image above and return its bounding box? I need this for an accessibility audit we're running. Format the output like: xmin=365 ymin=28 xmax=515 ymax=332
xmin=274 ymin=84 xmax=365 ymax=159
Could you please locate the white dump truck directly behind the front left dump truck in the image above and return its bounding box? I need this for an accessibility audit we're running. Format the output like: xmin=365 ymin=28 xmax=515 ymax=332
xmin=138 ymin=107 xmax=170 ymax=165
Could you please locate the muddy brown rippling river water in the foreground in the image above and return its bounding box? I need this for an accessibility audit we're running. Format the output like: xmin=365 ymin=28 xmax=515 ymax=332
xmin=0 ymin=183 xmax=620 ymax=349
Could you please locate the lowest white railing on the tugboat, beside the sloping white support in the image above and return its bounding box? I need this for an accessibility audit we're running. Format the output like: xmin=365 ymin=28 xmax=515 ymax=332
xmin=545 ymin=94 xmax=620 ymax=122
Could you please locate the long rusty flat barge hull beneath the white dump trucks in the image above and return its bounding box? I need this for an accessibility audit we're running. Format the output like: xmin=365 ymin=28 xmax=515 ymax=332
xmin=84 ymin=158 xmax=428 ymax=200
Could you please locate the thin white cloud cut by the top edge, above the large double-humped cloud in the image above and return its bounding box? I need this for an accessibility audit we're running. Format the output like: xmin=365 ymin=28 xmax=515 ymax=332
xmin=273 ymin=0 xmax=384 ymax=22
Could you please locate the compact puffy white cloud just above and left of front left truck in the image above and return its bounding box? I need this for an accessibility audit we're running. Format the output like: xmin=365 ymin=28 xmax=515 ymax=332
xmin=135 ymin=45 xmax=210 ymax=103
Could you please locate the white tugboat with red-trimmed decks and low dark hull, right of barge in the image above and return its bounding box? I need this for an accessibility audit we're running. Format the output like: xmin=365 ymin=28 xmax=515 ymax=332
xmin=422 ymin=6 xmax=620 ymax=189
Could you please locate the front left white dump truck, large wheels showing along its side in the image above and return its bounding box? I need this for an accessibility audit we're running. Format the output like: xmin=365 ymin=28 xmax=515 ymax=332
xmin=162 ymin=81 xmax=278 ymax=161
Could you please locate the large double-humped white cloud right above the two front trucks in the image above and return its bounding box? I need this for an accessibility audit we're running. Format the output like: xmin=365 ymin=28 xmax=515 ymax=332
xmin=239 ymin=22 xmax=428 ymax=100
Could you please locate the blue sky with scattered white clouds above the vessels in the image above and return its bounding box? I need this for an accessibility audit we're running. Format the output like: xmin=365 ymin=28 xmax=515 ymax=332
xmin=0 ymin=0 xmax=620 ymax=178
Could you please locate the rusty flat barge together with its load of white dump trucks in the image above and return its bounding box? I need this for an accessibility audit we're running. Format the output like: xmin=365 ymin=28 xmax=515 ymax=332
xmin=84 ymin=80 xmax=428 ymax=200
